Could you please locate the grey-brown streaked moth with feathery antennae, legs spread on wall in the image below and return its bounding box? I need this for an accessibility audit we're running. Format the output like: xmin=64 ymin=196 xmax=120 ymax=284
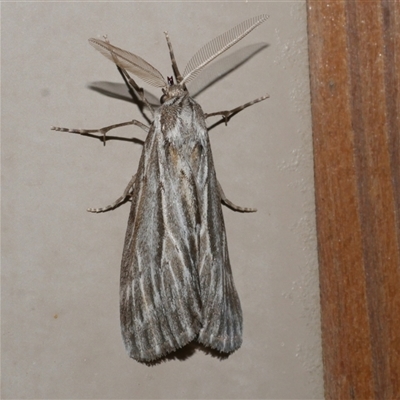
xmin=52 ymin=15 xmax=268 ymax=363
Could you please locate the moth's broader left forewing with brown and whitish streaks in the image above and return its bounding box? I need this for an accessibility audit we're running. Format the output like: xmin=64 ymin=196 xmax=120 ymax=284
xmin=120 ymin=121 xmax=201 ymax=362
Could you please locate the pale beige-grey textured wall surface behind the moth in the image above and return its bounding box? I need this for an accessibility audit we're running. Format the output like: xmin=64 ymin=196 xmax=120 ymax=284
xmin=2 ymin=2 xmax=323 ymax=399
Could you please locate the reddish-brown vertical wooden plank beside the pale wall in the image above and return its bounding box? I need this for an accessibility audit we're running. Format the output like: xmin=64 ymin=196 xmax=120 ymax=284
xmin=307 ymin=0 xmax=400 ymax=399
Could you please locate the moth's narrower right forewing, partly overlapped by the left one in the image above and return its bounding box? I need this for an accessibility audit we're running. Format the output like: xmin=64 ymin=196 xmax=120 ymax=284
xmin=198 ymin=138 xmax=242 ymax=353
